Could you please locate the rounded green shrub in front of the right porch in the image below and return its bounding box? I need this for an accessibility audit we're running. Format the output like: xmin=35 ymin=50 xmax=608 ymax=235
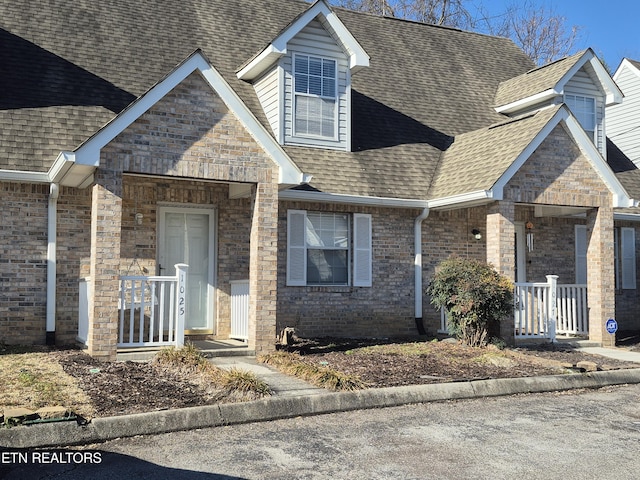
xmin=427 ymin=257 xmax=513 ymax=346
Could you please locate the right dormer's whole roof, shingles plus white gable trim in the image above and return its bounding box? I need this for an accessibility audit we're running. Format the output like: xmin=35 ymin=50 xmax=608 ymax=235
xmin=495 ymin=48 xmax=623 ymax=115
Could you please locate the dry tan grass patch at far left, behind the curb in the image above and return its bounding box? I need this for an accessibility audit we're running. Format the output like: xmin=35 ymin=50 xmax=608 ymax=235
xmin=0 ymin=347 xmax=94 ymax=416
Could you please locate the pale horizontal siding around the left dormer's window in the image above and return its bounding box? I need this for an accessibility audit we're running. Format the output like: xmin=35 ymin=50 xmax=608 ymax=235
xmin=280 ymin=20 xmax=349 ymax=149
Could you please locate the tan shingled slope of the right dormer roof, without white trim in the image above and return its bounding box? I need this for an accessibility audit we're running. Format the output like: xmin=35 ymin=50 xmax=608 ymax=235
xmin=494 ymin=51 xmax=585 ymax=106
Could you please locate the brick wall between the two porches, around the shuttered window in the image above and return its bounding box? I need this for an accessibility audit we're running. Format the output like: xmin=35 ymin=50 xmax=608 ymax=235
xmin=277 ymin=202 xmax=485 ymax=337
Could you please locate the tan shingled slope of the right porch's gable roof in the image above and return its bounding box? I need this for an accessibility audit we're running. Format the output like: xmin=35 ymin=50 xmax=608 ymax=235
xmin=429 ymin=106 xmax=562 ymax=198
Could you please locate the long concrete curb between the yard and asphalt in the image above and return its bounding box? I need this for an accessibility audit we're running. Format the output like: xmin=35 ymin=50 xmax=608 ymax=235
xmin=0 ymin=368 xmax=640 ymax=448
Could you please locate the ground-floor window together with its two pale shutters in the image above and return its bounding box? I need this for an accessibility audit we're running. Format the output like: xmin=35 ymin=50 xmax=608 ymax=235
xmin=287 ymin=210 xmax=372 ymax=286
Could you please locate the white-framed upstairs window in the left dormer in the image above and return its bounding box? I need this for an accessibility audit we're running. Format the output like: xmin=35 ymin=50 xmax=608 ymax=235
xmin=293 ymin=54 xmax=337 ymax=139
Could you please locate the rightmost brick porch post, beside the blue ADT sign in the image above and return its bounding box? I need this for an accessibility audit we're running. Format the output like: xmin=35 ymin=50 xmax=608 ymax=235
xmin=587 ymin=205 xmax=615 ymax=346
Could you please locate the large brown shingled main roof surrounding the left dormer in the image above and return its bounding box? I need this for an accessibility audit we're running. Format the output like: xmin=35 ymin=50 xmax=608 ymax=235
xmin=0 ymin=0 xmax=532 ymax=198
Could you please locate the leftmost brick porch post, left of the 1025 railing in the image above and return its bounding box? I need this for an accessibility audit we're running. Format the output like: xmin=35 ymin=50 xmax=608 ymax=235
xmin=87 ymin=169 xmax=122 ymax=361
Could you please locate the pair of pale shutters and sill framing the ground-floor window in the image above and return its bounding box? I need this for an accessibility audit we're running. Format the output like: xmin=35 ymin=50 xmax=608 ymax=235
xmin=287 ymin=210 xmax=373 ymax=287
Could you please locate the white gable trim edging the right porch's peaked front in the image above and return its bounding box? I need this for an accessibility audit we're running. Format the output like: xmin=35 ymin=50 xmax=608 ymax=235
xmin=492 ymin=106 xmax=638 ymax=208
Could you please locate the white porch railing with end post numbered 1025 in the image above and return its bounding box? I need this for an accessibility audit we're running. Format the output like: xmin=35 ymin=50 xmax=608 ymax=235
xmin=118 ymin=264 xmax=188 ymax=347
